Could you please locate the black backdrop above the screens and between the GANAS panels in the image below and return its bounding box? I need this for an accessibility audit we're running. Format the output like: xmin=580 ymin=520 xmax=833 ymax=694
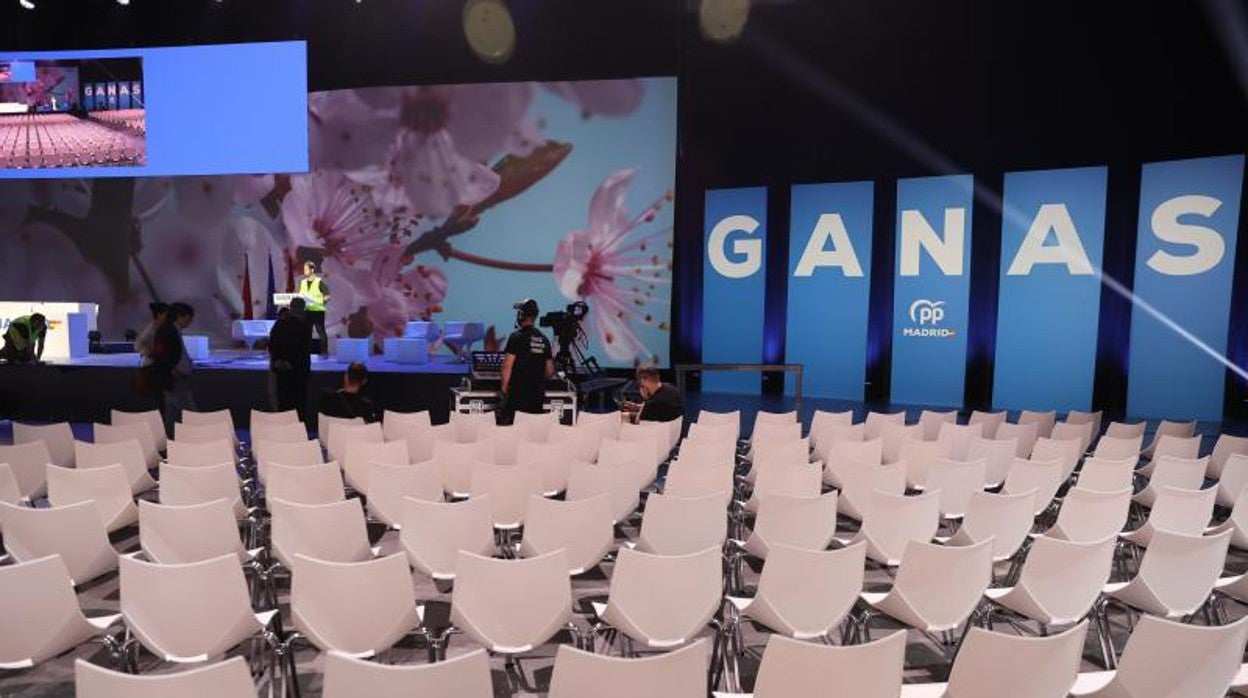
xmin=0 ymin=0 xmax=1248 ymax=417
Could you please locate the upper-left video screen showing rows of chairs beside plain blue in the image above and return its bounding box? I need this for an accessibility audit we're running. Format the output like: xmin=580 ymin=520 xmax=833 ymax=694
xmin=0 ymin=41 xmax=308 ymax=179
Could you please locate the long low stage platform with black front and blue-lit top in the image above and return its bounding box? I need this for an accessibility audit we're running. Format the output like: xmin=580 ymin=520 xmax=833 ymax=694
xmin=0 ymin=350 xmax=468 ymax=425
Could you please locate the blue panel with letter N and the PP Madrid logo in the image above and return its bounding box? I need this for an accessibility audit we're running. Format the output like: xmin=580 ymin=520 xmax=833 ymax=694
xmin=891 ymin=175 xmax=975 ymax=406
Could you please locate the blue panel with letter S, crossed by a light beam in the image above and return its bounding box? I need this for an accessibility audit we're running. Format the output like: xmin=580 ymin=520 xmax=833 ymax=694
xmin=1127 ymin=155 xmax=1244 ymax=420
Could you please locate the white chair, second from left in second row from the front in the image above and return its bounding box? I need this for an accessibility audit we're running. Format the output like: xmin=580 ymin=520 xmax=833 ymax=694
xmin=120 ymin=554 xmax=277 ymax=664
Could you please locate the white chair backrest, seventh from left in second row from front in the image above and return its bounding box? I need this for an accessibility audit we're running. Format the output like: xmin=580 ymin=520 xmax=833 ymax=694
xmin=890 ymin=541 xmax=992 ymax=628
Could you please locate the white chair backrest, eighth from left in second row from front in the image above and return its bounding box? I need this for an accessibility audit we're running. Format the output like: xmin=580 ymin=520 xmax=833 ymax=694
xmin=1017 ymin=536 xmax=1117 ymax=621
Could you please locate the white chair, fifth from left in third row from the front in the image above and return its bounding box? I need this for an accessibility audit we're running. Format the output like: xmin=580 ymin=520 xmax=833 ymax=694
xmin=520 ymin=494 xmax=615 ymax=574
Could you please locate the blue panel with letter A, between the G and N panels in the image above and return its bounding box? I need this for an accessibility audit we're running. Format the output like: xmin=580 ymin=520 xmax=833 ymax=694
xmin=785 ymin=182 xmax=872 ymax=400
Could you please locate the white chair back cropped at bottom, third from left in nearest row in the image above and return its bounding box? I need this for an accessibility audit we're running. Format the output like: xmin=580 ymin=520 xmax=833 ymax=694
xmin=549 ymin=639 xmax=710 ymax=698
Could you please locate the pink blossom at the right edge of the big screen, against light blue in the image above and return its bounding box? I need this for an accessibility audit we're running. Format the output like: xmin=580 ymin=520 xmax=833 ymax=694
xmin=554 ymin=170 xmax=671 ymax=361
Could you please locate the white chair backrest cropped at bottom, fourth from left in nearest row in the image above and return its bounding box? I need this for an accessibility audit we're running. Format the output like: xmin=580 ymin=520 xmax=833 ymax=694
xmin=754 ymin=632 xmax=906 ymax=698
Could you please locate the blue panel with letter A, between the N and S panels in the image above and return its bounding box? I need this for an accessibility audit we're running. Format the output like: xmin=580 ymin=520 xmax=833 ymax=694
xmin=992 ymin=167 xmax=1107 ymax=411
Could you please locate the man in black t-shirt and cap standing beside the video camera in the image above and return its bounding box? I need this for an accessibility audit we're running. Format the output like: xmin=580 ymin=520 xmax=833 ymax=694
xmin=497 ymin=298 xmax=554 ymax=425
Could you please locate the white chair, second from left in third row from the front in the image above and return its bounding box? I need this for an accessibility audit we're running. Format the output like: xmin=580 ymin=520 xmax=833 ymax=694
xmin=139 ymin=499 xmax=260 ymax=564
